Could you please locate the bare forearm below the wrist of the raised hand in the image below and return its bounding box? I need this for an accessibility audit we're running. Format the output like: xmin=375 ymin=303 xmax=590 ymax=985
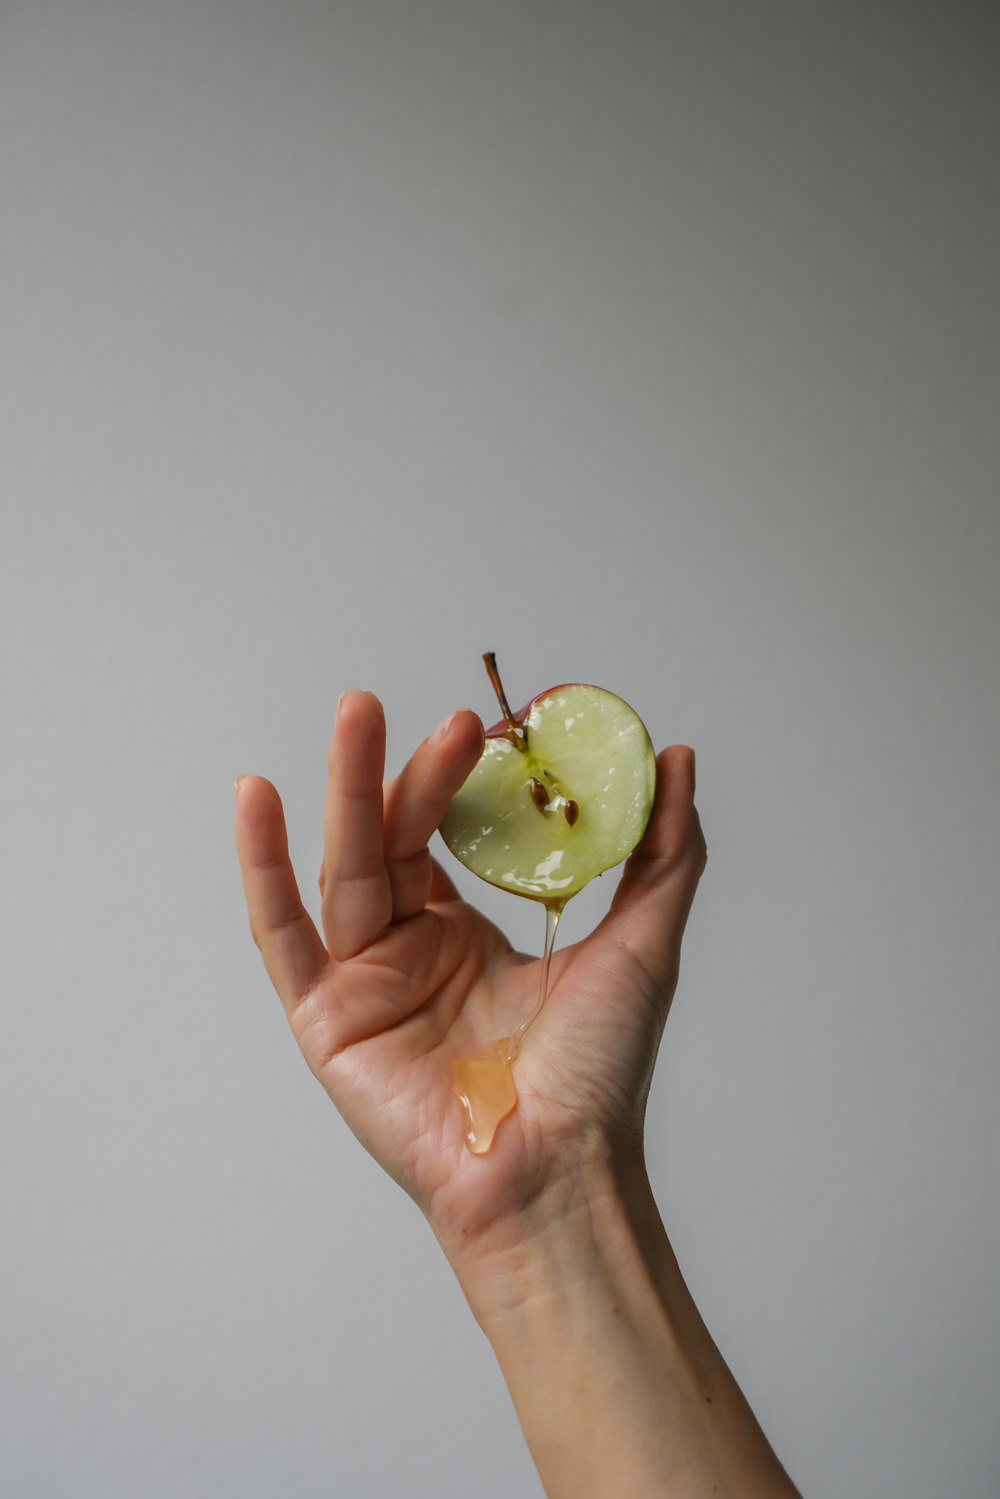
xmin=440 ymin=1160 xmax=796 ymax=1499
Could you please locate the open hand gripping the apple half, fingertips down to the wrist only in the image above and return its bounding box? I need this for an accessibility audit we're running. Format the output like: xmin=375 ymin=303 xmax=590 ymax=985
xmin=237 ymin=693 xmax=706 ymax=1261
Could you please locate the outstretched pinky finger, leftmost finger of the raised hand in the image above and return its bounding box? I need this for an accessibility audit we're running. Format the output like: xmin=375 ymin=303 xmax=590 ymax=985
xmin=235 ymin=775 xmax=330 ymax=1013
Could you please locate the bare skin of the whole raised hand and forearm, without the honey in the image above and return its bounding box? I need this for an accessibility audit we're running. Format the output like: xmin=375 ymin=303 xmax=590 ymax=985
xmin=237 ymin=693 xmax=796 ymax=1499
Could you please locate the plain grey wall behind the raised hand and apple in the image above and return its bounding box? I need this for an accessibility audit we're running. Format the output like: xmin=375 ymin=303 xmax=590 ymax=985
xmin=0 ymin=0 xmax=1000 ymax=1499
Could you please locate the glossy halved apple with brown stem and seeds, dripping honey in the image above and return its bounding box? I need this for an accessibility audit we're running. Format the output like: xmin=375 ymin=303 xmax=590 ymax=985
xmin=441 ymin=652 xmax=657 ymax=908
